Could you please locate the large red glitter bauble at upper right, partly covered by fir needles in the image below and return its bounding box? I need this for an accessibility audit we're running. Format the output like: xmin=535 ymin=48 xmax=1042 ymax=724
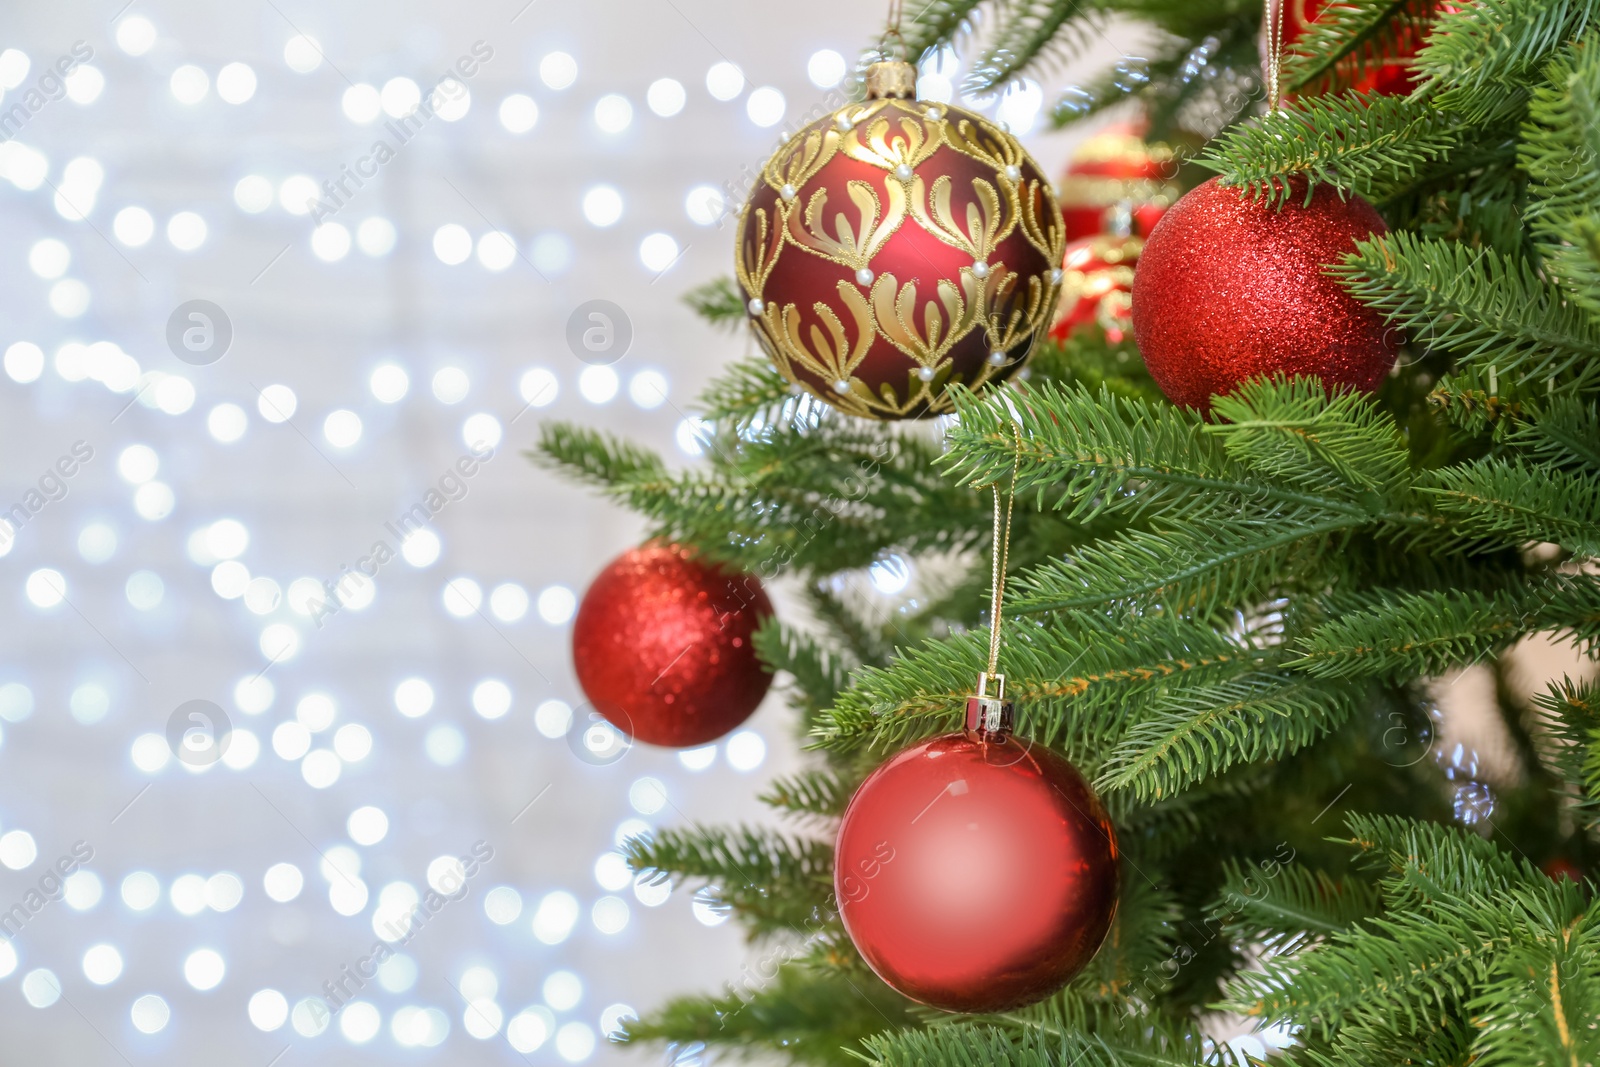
xmin=1133 ymin=178 xmax=1398 ymax=411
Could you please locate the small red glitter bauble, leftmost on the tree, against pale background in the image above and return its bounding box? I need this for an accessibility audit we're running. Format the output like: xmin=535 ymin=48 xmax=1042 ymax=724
xmin=573 ymin=542 xmax=773 ymax=749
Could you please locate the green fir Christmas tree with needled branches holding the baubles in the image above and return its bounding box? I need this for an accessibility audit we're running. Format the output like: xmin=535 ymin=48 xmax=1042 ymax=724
xmin=538 ymin=0 xmax=1600 ymax=1067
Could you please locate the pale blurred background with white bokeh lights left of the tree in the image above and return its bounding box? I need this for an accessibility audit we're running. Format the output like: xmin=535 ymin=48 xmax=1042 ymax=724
xmin=0 ymin=0 xmax=1136 ymax=1067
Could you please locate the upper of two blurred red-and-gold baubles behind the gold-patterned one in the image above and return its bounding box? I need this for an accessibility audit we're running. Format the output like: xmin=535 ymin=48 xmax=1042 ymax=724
xmin=1059 ymin=123 xmax=1182 ymax=242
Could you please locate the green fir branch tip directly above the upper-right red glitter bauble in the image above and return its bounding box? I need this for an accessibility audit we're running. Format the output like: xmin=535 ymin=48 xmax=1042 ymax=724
xmin=1197 ymin=92 xmax=1462 ymax=205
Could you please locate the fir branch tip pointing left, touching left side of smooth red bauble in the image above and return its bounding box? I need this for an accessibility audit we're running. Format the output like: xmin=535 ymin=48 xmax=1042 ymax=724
xmin=622 ymin=827 xmax=834 ymax=937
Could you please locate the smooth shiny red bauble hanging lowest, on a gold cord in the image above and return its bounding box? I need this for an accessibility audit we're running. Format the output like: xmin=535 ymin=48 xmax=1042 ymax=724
xmin=834 ymin=733 xmax=1118 ymax=1013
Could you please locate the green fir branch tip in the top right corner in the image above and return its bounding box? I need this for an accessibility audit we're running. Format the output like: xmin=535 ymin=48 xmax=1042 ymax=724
xmin=1416 ymin=0 xmax=1600 ymax=120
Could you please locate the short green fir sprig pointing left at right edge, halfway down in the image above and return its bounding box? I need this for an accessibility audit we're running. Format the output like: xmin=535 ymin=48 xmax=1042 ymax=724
xmin=1418 ymin=458 xmax=1600 ymax=557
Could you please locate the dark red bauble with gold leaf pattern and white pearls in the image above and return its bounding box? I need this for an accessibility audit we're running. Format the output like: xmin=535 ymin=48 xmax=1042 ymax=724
xmin=736 ymin=62 xmax=1066 ymax=419
